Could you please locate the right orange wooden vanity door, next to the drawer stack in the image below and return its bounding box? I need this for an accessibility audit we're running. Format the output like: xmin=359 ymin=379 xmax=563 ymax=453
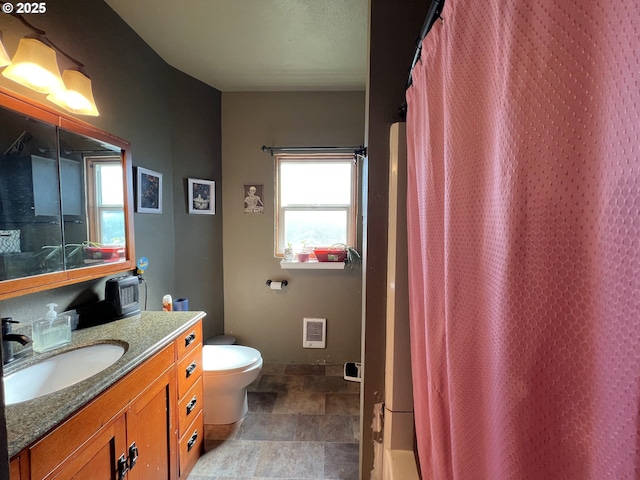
xmin=127 ymin=368 xmax=177 ymax=480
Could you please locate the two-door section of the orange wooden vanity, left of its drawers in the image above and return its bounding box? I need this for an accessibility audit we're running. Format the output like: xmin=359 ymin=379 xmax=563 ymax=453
xmin=29 ymin=345 xmax=175 ymax=480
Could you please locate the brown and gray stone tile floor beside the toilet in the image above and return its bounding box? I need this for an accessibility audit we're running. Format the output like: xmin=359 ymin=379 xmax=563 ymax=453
xmin=188 ymin=363 xmax=360 ymax=480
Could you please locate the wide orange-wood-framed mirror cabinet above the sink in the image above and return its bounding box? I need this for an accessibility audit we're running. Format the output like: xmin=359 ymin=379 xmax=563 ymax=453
xmin=0 ymin=88 xmax=134 ymax=299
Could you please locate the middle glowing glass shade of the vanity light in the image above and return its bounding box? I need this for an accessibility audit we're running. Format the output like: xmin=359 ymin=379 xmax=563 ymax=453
xmin=2 ymin=38 xmax=64 ymax=93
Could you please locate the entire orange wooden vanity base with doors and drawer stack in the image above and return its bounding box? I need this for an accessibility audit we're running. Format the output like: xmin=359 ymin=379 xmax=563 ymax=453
xmin=11 ymin=322 xmax=204 ymax=480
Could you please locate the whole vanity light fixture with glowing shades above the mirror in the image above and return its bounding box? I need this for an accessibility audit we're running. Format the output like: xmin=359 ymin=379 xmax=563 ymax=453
xmin=0 ymin=11 xmax=99 ymax=116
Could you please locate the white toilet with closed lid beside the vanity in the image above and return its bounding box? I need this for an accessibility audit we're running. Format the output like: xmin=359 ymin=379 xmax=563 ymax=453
xmin=202 ymin=345 xmax=262 ymax=425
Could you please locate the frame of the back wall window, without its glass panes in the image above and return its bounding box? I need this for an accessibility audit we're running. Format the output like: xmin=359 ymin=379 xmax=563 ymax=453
xmin=274 ymin=153 xmax=359 ymax=258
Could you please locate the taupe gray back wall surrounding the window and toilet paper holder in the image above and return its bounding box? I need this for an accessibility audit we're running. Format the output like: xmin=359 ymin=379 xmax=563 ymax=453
xmin=222 ymin=92 xmax=365 ymax=364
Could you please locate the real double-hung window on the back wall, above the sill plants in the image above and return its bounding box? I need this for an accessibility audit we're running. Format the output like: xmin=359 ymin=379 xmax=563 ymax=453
xmin=275 ymin=154 xmax=357 ymax=256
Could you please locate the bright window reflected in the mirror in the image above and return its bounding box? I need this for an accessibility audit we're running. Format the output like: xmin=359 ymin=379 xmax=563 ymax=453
xmin=87 ymin=157 xmax=125 ymax=245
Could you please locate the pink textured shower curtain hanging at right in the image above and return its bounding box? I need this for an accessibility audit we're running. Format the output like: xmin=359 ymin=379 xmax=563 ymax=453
xmin=407 ymin=0 xmax=640 ymax=480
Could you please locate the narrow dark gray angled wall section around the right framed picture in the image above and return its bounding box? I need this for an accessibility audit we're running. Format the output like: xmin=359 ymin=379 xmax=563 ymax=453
xmin=171 ymin=69 xmax=224 ymax=338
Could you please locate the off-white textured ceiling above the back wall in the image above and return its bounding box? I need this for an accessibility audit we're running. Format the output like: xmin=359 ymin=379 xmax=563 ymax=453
xmin=106 ymin=0 xmax=368 ymax=92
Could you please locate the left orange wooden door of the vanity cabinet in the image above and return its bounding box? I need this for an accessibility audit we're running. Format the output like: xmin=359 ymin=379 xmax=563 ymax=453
xmin=47 ymin=415 xmax=126 ymax=480
